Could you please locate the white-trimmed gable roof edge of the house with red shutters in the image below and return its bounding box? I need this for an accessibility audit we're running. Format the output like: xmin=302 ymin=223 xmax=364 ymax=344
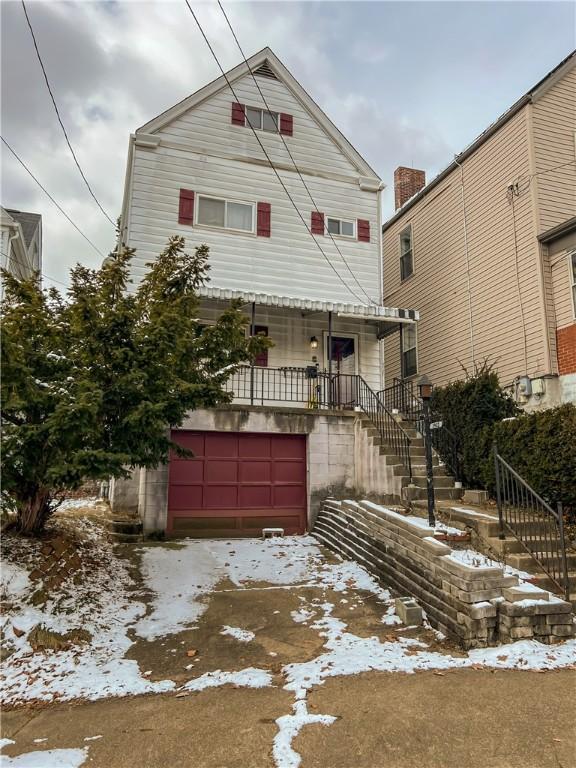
xmin=136 ymin=48 xmax=380 ymax=180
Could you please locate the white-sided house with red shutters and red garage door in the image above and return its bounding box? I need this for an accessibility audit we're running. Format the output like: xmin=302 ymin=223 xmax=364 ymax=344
xmin=112 ymin=48 xmax=428 ymax=536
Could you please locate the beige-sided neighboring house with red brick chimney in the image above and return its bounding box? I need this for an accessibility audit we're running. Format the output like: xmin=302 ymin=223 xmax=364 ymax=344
xmin=382 ymin=52 xmax=576 ymax=409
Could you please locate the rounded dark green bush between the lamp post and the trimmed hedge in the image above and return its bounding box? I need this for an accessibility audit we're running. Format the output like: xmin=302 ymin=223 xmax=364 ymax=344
xmin=431 ymin=363 xmax=520 ymax=488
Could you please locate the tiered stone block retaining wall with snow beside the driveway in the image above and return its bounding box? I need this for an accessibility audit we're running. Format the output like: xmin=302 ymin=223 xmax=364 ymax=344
xmin=312 ymin=499 xmax=574 ymax=648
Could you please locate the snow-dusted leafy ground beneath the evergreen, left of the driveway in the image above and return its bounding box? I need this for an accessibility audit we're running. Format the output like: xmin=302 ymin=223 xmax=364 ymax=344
xmin=1 ymin=521 xmax=175 ymax=704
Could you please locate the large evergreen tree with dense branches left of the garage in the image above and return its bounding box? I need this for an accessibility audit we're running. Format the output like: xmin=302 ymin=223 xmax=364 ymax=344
xmin=1 ymin=237 xmax=268 ymax=534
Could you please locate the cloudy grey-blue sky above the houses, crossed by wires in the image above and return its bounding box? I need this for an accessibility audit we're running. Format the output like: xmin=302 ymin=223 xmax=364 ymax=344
xmin=0 ymin=0 xmax=576 ymax=284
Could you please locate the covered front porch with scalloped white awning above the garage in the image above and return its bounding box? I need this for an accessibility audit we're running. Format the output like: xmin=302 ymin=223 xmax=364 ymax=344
xmin=200 ymin=286 xmax=418 ymax=409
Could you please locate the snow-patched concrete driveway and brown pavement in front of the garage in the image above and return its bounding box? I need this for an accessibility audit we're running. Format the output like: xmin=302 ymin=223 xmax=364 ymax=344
xmin=2 ymin=537 xmax=576 ymax=768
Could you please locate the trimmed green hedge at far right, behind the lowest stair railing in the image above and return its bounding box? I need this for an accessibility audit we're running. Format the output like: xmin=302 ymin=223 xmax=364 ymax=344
xmin=484 ymin=403 xmax=576 ymax=515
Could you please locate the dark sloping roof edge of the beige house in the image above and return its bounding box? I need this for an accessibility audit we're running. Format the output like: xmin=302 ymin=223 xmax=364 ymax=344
xmin=382 ymin=50 xmax=576 ymax=232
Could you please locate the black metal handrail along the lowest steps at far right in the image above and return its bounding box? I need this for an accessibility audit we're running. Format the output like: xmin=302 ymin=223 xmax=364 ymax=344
xmin=493 ymin=444 xmax=570 ymax=600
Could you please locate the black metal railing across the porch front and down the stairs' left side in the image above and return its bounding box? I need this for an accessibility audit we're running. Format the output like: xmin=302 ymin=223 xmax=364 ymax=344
xmin=226 ymin=366 xmax=412 ymax=482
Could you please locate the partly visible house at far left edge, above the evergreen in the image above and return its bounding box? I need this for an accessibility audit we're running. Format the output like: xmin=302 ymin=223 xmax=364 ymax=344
xmin=0 ymin=208 xmax=42 ymax=278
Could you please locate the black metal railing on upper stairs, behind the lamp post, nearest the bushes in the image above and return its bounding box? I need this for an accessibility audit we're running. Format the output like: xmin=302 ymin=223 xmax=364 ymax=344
xmin=378 ymin=378 xmax=464 ymax=481
